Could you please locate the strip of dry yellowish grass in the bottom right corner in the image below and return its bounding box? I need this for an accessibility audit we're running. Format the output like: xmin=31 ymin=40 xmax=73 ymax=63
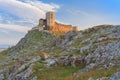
xmin=76 ymin=66 xmax=120 ymax=80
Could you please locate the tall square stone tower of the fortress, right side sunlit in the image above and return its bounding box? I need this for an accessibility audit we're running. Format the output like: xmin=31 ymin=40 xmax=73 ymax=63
xmin=46 ymin=12 xmax=55 ymax=30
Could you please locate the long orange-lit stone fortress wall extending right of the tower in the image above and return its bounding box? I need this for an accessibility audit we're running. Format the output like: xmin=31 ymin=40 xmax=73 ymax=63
xmin=50 ymin=22 xmax=72 ymax=33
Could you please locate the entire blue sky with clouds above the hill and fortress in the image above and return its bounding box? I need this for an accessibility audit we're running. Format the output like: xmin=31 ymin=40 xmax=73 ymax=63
xmin=0 ymin=0 xmax=120 ymax=45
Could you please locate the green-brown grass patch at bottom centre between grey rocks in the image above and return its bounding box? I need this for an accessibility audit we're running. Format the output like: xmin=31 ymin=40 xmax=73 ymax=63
xmin=33 ymin=63 xmax=82 ymax=80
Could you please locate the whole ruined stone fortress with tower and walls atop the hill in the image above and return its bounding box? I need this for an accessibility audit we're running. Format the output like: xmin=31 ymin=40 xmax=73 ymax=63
xmin=37 ymin=12 xmax=78 ymax=33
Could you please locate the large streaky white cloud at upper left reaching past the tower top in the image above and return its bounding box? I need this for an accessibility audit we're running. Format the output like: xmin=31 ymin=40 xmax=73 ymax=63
xmin=0 ymin=0 xmax=60 ymax=26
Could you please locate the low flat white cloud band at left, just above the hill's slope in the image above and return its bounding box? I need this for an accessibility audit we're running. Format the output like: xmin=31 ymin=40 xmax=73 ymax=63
xmin=0 ymin=24 xmax=31 ymax=33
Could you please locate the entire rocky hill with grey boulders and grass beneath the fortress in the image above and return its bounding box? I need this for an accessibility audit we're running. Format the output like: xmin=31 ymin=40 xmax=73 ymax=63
xmin=0 ymin=25 xmax=120 ymax=80
